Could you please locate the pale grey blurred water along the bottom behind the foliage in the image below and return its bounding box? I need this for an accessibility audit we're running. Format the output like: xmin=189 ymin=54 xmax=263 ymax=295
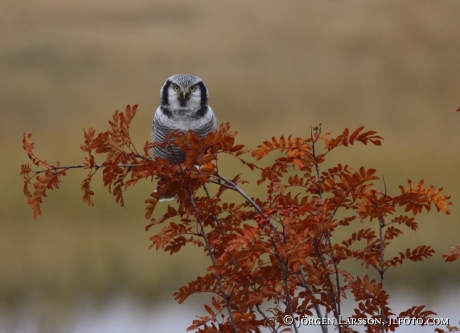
xmin=0 ymin=289 xmax=460 ymax=333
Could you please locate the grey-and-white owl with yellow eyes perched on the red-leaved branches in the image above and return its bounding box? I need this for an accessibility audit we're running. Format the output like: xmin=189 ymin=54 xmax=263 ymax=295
xmin=152 ymin=74 xmax=217 ymax=201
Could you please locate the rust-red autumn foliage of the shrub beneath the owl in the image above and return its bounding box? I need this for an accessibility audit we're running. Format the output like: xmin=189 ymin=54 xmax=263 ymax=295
xmin=21 ymin=105 xmax=460 ymax=332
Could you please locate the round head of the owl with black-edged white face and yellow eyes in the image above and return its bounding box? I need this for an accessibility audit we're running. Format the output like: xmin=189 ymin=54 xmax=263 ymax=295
xmin=160 ymin=74 xmax=208 ymax=111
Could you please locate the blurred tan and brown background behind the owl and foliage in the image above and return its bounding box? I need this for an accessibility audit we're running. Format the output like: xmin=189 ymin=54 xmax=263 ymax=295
xmin=0 ymin=0 xmax=460 ymax=333
